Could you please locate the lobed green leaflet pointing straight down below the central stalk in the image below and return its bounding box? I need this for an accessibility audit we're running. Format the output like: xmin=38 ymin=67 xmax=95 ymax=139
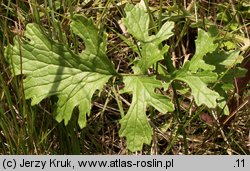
xmin=119 ymin=76 xmax=174 ymax=151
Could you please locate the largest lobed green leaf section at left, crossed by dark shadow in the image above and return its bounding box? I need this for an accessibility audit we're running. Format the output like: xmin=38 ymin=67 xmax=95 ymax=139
xmin=8 ymin=15 xmax=116 ymax=128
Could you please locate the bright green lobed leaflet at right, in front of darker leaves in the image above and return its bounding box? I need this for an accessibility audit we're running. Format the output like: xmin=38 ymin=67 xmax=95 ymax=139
xmin=173 ymin=27 xmax=221 ymax=108
